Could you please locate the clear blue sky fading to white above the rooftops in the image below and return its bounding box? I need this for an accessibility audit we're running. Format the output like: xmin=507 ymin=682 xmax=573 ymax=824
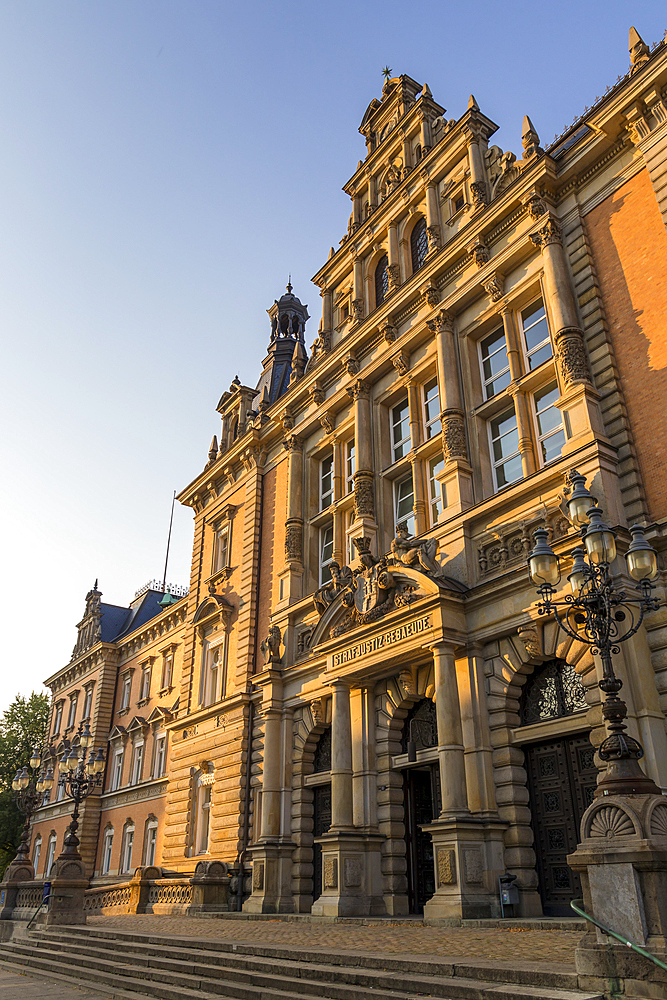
xmin=0 ymin=0 xmax=667 ymax=709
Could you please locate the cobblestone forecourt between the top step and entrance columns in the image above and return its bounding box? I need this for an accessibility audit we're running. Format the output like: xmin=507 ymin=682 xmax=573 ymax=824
xmin=88 ymin=914 xmax=582 ymax=968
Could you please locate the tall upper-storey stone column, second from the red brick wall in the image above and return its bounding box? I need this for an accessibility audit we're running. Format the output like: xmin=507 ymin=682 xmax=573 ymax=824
xmin=427 ymin=309 xmax=473 ymax=516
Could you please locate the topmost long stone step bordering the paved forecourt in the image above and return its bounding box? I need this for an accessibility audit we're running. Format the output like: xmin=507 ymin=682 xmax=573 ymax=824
xmin=39 ymin=927 xmax=582 ymax=997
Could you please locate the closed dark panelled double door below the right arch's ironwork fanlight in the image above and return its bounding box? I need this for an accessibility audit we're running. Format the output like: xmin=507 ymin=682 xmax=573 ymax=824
xmin=525 ymin=736 xmax=598 ymax=917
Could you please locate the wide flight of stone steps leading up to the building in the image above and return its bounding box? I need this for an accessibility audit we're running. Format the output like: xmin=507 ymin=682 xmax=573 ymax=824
xmin=0 ymin=927 xmax=603 ymax=1000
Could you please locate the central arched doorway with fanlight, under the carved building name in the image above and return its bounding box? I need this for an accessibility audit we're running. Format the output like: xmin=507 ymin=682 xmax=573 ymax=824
xmin=401 ymin=698 xmax=441 ymax=913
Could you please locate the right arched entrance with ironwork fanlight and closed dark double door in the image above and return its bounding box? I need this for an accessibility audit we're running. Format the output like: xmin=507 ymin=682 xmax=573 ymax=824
xmin=520 ymin=660 xmax=598 ymax=916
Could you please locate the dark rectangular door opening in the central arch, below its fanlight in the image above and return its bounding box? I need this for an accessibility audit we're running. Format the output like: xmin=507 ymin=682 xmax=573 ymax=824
xmin=404 ymin=767 xmax=440 ymax=913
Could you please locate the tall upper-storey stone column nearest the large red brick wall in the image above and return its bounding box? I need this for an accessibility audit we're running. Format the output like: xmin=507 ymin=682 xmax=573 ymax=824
xmin=530 ymin=215 xmax=605 ymax=455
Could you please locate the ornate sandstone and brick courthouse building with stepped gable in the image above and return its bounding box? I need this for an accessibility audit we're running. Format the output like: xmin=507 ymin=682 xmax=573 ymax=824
xmin=33 ymin=29 xmax=667 ymax=918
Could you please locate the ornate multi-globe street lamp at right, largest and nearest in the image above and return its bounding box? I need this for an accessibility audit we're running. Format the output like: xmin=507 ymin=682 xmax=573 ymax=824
xmin=528 ymin=471 xmax=660 ymax=797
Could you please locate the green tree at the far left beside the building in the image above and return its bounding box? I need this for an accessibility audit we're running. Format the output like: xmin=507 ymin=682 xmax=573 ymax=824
xmin=0 ymin=691 xmax=49 ymax=877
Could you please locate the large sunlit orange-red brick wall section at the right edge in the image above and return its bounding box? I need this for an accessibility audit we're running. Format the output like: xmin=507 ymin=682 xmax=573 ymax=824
xmin=586 ymin=170 xmax=667 ymax=520
